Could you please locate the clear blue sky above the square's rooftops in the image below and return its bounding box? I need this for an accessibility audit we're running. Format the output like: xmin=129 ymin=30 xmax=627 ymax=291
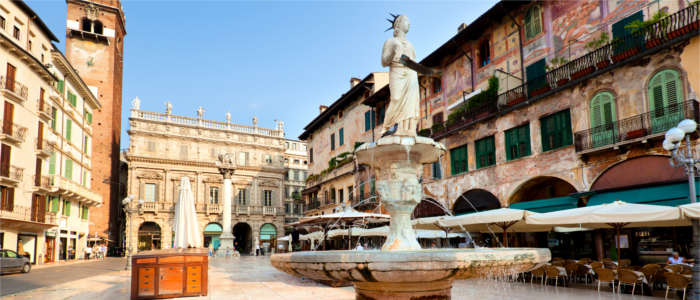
xmin=27 ymin=0 xmax=496 ymax=148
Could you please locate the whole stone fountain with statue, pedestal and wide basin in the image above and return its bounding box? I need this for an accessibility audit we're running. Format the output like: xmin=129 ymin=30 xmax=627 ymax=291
xmin=270 ymin=16 xmax=551 ymax=300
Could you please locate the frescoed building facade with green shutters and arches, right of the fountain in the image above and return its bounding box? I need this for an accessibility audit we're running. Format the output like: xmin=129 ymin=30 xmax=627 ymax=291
xmin=416 ymin=0 xmax=700 ymax=258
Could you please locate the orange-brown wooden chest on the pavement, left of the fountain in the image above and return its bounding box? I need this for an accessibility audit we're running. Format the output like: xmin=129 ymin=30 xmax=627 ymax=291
xmin=131 ymin=249 xmax=209 ymax=299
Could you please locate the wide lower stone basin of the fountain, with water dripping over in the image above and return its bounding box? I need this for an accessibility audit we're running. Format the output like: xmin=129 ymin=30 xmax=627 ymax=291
xmin=270 ymin=248 xmax=551 ymax=286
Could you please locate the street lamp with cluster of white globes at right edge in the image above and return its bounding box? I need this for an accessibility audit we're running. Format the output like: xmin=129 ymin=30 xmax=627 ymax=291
xmin=662 ymin=119 xmax=700 ymax=299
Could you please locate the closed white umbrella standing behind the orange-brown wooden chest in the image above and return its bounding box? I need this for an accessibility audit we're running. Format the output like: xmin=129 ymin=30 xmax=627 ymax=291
xmin=173 ymin=176 xmax=202 ymax=248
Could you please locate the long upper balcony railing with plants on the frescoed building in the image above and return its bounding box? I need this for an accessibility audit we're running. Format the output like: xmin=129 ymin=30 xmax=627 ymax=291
xmin=431 ymin=3 xmax=700 ymax=139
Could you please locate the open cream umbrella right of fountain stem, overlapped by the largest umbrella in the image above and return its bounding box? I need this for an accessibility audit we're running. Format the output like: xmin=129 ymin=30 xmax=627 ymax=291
xmin=438 ymin=208 xmax=552 ymax=247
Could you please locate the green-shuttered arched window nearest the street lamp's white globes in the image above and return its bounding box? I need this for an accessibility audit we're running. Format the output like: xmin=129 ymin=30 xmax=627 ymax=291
xmin=648 ymin=69 xmax=683 ymax=133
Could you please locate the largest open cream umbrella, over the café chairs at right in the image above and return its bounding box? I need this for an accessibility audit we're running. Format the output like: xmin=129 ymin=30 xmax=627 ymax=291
xmin=525 ymin=200 xmax=689 ymax=260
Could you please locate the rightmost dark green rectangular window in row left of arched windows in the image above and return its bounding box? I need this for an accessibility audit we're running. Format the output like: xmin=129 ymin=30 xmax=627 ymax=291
xmin=540 ymin=109 xmax=573 ymax=151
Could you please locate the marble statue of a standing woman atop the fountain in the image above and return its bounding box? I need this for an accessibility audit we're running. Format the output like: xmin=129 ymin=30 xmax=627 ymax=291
xmin=382 ymin=15 xmax=420 ymax=136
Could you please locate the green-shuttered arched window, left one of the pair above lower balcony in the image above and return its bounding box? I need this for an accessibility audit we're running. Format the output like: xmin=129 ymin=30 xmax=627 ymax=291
xmin=590 ymin=92 xmax=616 ymax=147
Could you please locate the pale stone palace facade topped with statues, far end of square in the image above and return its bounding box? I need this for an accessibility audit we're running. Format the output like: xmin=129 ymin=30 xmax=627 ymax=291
xmin=124 ymin=102 xmax=287 ymax=254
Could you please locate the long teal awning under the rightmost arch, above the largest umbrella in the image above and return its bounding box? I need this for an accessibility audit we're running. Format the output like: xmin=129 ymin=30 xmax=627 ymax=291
xmin=587 ymin=181 xmax=700 ymax=206
